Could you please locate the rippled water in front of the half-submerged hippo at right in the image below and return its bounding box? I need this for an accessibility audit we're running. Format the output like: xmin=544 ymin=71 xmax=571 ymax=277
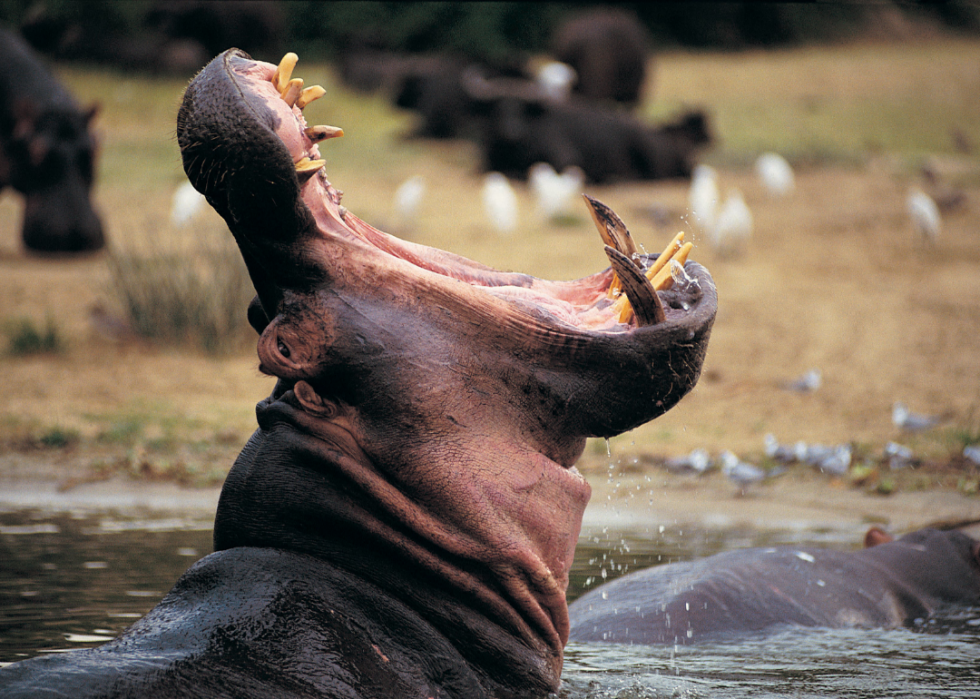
xmin=559 ymin=628 xmax=980 ymax=699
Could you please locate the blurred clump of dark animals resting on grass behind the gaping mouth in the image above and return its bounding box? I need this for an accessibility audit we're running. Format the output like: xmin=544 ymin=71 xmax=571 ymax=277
xmin=339 ymin=9 xmax=712 ymax=183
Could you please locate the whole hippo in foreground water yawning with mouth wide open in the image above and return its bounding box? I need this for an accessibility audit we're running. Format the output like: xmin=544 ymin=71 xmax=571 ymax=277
xmin=0 ymin=50 xmax=717 ymax=699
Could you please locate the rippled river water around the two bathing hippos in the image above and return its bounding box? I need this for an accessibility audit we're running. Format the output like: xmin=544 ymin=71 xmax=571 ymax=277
xmin=0 ymin=509 xmax=980 ymax=699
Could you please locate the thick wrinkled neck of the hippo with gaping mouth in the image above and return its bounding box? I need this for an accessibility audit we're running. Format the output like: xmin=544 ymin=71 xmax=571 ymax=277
xmin=214 ymin=393 xmax=589 ymax=693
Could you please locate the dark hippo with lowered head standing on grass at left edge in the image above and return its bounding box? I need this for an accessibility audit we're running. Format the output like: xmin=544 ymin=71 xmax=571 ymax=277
xmin=0 ymin=27 xmax=105 ymax=253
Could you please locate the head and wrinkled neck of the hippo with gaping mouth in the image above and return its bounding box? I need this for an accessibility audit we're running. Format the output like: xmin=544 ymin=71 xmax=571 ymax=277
xmin=177 ymin=50 xmax=717 ymax=691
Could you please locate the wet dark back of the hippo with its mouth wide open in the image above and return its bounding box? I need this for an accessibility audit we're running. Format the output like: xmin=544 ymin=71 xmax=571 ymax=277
xmin=0 ymin=548 xmax=506 ymax=699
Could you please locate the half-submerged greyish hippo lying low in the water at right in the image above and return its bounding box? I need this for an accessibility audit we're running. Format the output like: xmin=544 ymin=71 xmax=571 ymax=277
xmin=569 ymin=528 xmax=980 ymax=645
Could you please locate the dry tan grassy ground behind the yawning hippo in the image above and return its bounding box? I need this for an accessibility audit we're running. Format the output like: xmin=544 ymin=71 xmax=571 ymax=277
xmin=0 ymin=40 xmax=980 ymax=486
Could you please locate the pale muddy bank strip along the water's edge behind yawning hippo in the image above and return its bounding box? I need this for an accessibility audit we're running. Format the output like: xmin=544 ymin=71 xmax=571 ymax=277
xmin=0 ymin=454 xmax=980 ymax=541
